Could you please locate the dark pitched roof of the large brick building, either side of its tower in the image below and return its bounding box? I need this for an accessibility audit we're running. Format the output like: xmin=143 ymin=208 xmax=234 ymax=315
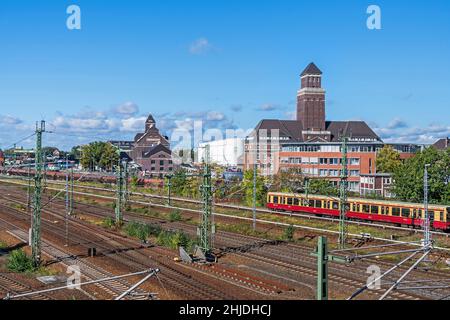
xmin=251 ymin=119 xmax=382 ymax=142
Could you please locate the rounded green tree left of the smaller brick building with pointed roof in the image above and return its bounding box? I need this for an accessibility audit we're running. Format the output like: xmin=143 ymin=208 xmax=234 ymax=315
xmin=80 ymin=141 xmax=119 ymax=170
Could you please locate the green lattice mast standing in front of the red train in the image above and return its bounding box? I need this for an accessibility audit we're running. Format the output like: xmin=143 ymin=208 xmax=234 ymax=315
xmin=339 ymin=137 xmax=348 ymax=249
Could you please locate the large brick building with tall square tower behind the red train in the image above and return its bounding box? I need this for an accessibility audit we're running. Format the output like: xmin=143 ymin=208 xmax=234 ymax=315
xmin=244 ymin=63 xmax=417 ymax=192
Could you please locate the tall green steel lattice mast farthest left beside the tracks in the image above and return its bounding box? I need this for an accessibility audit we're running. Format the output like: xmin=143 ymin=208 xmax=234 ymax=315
xmin=31 ymin=121 xmax=45 ymax=267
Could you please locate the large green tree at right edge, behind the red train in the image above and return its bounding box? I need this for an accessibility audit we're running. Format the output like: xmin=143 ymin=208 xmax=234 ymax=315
xmin=393 ymin=148 xmax=450 ymax=204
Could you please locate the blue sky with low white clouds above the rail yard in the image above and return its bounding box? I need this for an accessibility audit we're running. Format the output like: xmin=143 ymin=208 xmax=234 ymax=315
xmin=0 ymin=0 xmax=450 ymax=149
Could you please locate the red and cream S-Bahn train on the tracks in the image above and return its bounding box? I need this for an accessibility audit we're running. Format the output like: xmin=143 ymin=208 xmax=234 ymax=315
xmin=267 ymin=192 xmax=450 ymax=232
